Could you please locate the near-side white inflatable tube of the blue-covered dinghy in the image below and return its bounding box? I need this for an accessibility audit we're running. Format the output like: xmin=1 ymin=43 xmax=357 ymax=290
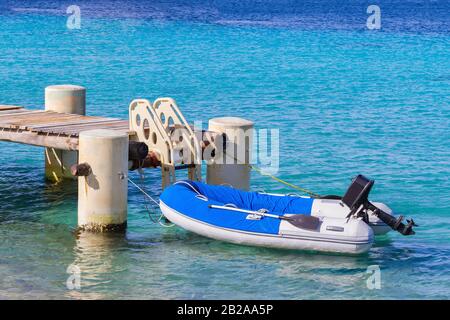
xmin=160 ymin=201 xmax=373 ymax=254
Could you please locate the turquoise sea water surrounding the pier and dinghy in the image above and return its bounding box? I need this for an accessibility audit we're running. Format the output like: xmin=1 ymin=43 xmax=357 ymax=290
xmin=0 ymin=0 xmax=450 ymax=299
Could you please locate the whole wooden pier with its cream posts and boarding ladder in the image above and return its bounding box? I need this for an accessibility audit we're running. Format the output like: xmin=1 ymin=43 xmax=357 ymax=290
xmin=0 ymin=85 xmax=253 ymax=231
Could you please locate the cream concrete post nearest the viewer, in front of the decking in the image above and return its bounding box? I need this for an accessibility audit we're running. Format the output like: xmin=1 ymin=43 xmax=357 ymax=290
xmin=78 ymin=129 xmax=129 ymax=232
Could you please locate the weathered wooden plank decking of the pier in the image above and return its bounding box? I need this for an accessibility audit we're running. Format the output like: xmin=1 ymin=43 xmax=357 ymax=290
xmin=0 ymin=105 xmax=133 ymax=150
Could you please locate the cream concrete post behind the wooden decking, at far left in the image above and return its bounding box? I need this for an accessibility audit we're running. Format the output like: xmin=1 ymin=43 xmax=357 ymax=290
xmin=45 ymin=85 xmax=86 ymax=182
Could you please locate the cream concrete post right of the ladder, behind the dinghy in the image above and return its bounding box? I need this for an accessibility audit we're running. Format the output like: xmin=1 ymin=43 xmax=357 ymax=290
xmin=206 ymin=117 xmax=253 ymax=190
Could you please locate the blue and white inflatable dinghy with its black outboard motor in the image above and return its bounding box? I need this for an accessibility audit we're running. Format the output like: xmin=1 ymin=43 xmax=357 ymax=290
xmin=160 ymin=176 xmax=414 ymax=254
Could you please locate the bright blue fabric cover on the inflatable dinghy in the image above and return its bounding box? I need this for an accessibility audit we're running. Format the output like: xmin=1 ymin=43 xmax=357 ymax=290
xmin=160 ymin=181 xmax=314 ymax=234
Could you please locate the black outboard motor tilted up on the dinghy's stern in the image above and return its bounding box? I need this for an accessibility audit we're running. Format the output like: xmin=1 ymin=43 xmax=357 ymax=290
xmin=341 ymin=175 xmax=417 ymax=236
